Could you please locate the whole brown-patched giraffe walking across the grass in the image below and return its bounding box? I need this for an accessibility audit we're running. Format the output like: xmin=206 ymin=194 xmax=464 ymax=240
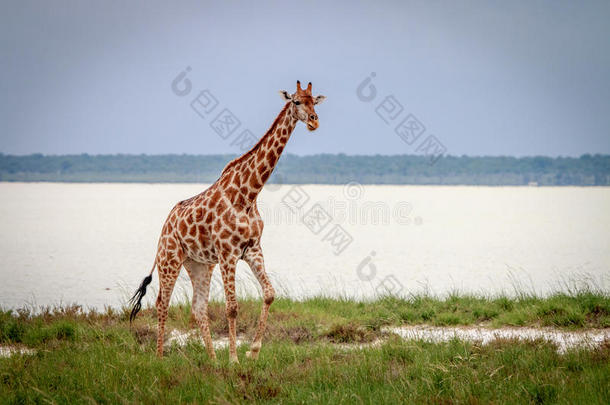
xmin=130 ymin=81 xmax=325 ymax=363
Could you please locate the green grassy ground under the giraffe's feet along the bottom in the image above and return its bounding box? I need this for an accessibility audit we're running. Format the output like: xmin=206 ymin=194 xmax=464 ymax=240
xmin=0 ymin=292 xmax=610 ymax=403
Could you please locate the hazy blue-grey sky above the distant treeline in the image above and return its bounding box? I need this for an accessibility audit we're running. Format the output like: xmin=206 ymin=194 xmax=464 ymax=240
xmin=0 ymin=0 xmax=610 ymax=156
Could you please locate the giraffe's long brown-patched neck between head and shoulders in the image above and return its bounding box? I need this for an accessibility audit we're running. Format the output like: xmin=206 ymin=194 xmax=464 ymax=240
xmin=219 ymin=102 xmax=297 ymax=205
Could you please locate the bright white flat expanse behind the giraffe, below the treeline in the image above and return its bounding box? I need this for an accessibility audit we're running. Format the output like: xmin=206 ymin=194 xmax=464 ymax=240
xmin=0 ymin=183 xmax=610 ymax=309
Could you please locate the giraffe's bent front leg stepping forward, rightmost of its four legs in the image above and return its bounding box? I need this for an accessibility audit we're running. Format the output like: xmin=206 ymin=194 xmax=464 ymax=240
xmin=244 ymin=246 xmax=275 ymax=359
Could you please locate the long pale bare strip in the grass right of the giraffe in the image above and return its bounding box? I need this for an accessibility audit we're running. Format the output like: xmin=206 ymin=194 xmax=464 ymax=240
xmin=382 ymin=325 xmax=610 ymax=353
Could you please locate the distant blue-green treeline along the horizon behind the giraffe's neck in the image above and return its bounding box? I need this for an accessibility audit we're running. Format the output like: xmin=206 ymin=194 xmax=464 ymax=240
xmin=0 ymin=154 xmax=610 ymax=186
